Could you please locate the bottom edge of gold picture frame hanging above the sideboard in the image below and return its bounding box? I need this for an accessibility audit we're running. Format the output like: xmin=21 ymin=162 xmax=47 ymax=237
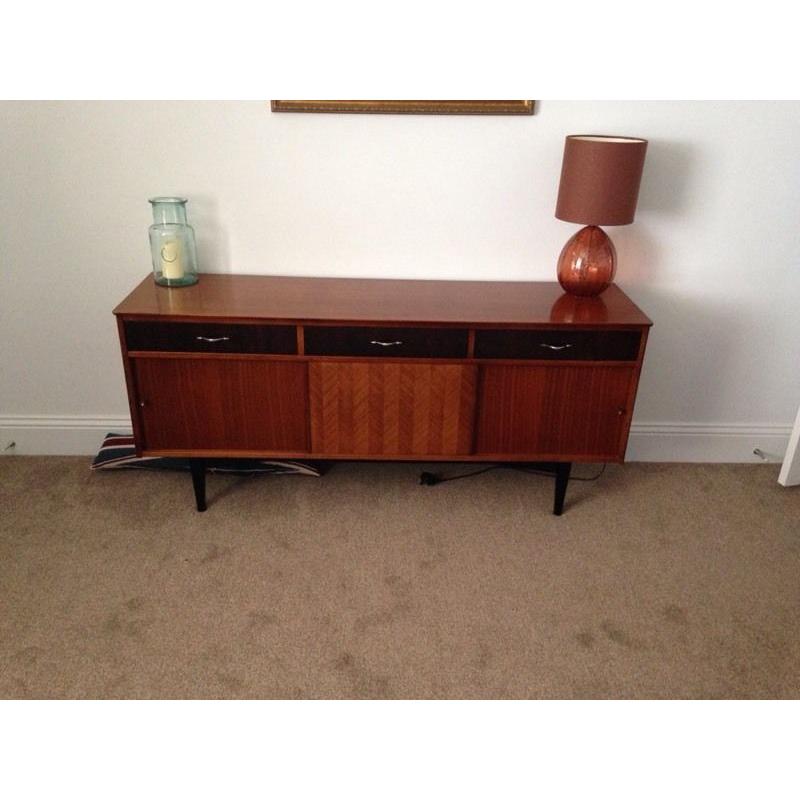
xmin=270 ymin=100 xmax=534 ymax=116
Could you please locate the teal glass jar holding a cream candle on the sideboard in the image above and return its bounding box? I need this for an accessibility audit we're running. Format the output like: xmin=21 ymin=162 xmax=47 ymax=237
xmin=149 ymin=197 xmax=197 ymax=286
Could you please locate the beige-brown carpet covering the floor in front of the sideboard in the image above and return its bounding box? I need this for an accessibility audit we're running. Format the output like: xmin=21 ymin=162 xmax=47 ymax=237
xmin=0 ymin=456 xmax=800 ymax=698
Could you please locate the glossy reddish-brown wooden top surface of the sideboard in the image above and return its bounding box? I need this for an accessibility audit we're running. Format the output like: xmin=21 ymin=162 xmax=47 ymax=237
xmin=114 ymin=274 xmax=652 ymax=327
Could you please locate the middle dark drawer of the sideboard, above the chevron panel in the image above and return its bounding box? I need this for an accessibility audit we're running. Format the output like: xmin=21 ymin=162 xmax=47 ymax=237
xmin=305 ymin=325 xmax=469 ymax=358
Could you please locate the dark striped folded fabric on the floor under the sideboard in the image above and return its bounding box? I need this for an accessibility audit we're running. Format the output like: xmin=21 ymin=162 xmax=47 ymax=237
xmin=92 ymin=433 xmax=324 ymax=478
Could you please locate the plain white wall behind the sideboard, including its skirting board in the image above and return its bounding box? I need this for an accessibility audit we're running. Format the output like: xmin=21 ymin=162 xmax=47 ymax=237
xmin=0 ymin=101 xmax=800 ymax=460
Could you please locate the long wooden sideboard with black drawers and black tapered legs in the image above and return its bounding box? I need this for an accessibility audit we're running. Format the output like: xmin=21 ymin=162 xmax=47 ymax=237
xmin=114 ymin=274 xmax=652 ymax=513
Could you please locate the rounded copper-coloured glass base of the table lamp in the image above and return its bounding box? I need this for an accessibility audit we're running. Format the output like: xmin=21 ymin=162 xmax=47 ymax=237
xmin=558 ymin=225 xmax=617 ymax=297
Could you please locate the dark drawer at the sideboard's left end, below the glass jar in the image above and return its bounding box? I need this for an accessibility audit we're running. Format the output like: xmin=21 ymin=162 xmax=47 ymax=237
xmin=125 ymin=321 xmax=297 ymax=354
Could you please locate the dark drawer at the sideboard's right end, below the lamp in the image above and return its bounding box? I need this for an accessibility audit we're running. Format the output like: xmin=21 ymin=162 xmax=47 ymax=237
xmin=475 ymin=328 xmax=641 ymax=361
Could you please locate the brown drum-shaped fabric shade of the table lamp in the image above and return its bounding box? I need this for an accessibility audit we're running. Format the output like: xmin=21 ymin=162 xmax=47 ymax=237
xmin=556 ymin=136 xmax=647 ymax=225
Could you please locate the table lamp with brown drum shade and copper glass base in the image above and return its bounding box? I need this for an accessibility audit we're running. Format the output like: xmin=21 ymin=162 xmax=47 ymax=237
xmin=556 ymin=136 xmax=647 ymax=297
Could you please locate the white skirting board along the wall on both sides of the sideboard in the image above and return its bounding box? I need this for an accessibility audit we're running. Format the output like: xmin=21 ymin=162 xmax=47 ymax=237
xmin=0 ymin=416 xmax=792 ymax=463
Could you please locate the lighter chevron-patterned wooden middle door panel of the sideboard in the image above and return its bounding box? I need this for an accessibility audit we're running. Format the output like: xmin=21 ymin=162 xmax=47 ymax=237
xmin=309 ymin=361 xmax=477 ymax=457
